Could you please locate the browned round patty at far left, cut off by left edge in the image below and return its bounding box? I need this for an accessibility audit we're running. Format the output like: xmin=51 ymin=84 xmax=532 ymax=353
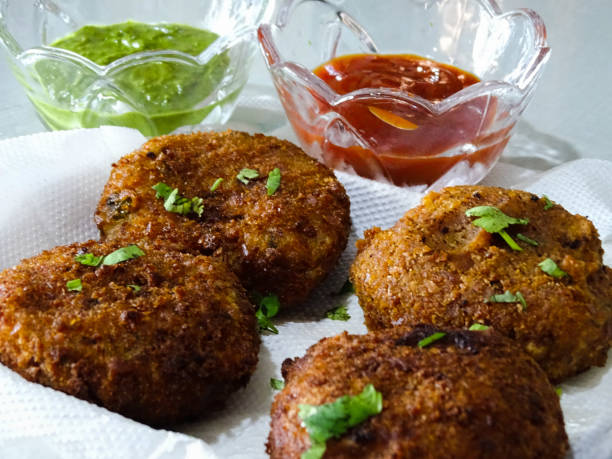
xmin=0 ymin=241 xmax=259 ymax=425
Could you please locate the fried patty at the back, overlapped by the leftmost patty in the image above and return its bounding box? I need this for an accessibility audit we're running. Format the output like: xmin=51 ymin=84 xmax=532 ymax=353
xmin=95 ymin=131 xmax=350 ymax=307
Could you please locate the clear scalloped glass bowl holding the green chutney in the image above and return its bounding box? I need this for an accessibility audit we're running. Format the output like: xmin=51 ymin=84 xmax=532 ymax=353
xmin=0 ymin=0 xmax=273 ymax=136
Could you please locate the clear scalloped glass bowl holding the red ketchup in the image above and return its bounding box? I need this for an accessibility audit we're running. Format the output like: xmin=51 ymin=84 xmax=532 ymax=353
xmin=258 ymin=0 xmax=550 ymax=189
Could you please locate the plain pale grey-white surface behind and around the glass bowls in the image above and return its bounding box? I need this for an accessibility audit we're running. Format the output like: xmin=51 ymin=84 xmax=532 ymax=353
xmin=0 ymin=0 xmax=612 ymax=169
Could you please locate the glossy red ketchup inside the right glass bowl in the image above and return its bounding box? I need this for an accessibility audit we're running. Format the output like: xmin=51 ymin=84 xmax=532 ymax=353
xmin=289 ymin=54 xmax=511 ymax=186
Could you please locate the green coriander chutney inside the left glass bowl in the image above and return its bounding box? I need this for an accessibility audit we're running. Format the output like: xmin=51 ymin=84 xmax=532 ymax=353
xmin=33 ymin=21 xmax=237 ymax=136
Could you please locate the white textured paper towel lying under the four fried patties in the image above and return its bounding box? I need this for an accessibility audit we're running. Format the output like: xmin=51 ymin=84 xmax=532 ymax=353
xmin=0 ymin=127 xmax=612 ymax=459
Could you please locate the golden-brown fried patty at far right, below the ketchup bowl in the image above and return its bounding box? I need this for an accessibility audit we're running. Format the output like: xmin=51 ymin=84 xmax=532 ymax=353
xmin=351 ymin=186 xmax=612 ymax=381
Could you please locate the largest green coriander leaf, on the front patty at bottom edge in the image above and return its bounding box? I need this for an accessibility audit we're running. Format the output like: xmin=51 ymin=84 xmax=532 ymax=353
xmin=298 ymin=384 xmax=382 ymax=459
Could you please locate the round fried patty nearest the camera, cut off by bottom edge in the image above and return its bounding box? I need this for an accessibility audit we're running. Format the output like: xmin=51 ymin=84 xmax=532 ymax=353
xmin=268 ymin=326 xmax=568 ymax=459
